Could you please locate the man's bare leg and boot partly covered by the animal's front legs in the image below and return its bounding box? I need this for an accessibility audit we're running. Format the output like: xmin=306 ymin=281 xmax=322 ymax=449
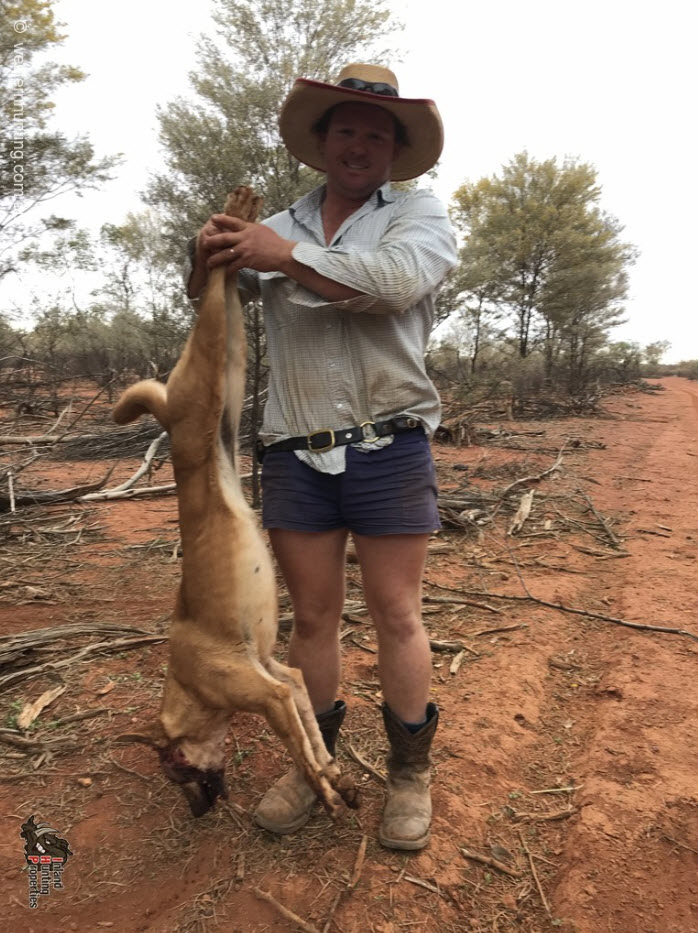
xmin=254 ymin=528 xmax=347 ymax=834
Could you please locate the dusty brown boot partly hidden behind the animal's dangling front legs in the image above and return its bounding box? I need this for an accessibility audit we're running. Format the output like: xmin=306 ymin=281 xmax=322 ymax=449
xmin=252 ymin=700 xmax=347 ymax=836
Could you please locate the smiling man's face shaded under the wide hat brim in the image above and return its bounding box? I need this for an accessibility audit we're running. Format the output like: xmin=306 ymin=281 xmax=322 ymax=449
xmin=321 ymin=103 xmax=398 ymax=202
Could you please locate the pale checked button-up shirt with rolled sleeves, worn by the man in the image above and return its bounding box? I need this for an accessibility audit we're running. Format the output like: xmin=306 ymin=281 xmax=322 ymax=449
xmin=239 ymin=183 xmax=457 ymax=473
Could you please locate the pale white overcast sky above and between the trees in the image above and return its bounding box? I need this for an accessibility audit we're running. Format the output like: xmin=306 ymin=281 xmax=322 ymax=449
xmin=8 ymin=0 xmax=698 ymax=361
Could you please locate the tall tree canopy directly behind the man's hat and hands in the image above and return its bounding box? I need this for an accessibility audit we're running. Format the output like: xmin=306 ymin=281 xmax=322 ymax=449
xmin=146 ymin=0 xmax=396 ymax=249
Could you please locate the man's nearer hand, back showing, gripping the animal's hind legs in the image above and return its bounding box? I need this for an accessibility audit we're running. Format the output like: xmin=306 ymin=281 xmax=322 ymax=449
xmin=204 ymin=214 xmax=296 ymax=272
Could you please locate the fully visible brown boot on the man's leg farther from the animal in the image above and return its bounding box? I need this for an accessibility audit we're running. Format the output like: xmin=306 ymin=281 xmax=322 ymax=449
xmin=378 ymin=703 xmax=439 ymax=849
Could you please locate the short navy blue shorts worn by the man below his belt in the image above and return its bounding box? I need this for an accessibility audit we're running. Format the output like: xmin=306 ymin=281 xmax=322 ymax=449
xmin=262 ymin=430 xmax=441 ymax=535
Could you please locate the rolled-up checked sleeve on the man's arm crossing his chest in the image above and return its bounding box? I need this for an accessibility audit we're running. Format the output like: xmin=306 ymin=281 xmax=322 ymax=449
xmin=292 ymin=191 xmax=457 ymax=314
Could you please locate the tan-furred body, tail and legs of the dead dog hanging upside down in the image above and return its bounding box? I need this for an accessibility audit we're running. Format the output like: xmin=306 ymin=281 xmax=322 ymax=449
xmin=114 ymin=188 xmax=354 ymax=816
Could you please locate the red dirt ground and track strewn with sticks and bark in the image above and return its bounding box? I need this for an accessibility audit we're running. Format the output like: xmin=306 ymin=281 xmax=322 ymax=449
xmin=0 ymin=379 xmax=698 ymax=933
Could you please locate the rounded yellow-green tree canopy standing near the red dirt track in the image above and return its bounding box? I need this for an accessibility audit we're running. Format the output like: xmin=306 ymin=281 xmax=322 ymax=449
xmin=451 ymin=152 xmax=634 ymax=388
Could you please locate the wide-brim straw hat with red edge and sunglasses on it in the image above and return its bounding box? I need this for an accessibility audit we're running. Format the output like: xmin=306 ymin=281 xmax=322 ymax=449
xmin=279 ymin=64 xmax=444 ymax=181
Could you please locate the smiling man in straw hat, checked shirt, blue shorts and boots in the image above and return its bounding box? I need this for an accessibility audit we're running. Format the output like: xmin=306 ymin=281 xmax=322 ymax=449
xmin=189 ymin=65 xmax=456 ymax=849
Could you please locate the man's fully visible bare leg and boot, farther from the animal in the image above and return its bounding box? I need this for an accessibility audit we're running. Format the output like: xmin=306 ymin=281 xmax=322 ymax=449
xmin=354 ymin=534 xmax=438 ymax=850
